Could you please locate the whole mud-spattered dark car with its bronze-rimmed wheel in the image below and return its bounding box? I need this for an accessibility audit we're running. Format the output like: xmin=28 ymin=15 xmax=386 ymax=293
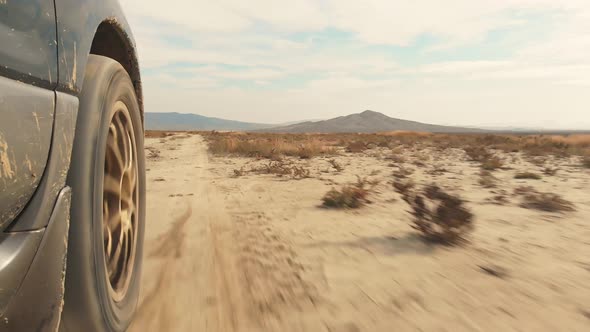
xmin=0 ymin=0 xmax=145 ymax=332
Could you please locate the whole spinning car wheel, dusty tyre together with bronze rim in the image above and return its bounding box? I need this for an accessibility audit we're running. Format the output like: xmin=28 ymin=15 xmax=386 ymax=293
xmin=60 ymin=55 xmax=145 ymax=332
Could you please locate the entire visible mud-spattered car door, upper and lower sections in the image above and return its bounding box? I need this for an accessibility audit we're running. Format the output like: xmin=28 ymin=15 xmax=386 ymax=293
xmin=0 ymin=0 xmax=58 ymax=230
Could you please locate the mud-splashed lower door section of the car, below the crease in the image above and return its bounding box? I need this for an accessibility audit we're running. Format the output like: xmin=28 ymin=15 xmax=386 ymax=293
xmin=0 ymin=76 xmax=55 ymax=230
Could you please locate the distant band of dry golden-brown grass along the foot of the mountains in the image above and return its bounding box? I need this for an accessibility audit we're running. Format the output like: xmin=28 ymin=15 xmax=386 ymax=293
xmin=201 ymin=132 xmax=590 ymax=160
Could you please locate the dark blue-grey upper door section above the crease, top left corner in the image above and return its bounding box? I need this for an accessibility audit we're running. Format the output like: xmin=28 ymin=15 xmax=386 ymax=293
xmin=0 ymin=0 xmax=58 ymax=89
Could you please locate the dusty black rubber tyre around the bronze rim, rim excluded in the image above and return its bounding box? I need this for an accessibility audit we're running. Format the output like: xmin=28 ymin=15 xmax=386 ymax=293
xmin=64 ymin=55 xmax=145 ymax=331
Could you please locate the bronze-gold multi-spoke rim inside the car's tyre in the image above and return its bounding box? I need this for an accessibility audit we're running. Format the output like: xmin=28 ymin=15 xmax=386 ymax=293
xmin=102 ymin=101 xmax=139 ymax=302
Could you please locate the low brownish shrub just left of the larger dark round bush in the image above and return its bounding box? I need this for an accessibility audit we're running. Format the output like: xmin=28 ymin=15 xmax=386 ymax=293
xmin=322 ymin=177 xmax=371 ymax=209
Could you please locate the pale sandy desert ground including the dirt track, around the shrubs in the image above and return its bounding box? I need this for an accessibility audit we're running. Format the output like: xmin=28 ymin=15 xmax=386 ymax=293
xmin=130 ymin=135 xmax=590 ymax=332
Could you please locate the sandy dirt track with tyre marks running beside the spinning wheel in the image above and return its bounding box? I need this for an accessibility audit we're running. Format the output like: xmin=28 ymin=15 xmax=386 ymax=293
xmin=130 ymin=136 xmax=326 ymax=332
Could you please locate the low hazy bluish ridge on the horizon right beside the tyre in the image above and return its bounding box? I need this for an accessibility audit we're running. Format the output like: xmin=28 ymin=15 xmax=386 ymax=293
xmin=145 ymin=112 xmax=276 ymax=131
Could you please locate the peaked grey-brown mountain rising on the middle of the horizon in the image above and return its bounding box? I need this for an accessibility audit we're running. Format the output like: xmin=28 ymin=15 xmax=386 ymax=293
xmin=257 ymin=111 xmax=487 ymax=133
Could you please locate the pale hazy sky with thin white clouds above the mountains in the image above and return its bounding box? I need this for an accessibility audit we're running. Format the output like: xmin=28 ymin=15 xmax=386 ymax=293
xmin=121 ymin=0 xmax=590 ymax=129
